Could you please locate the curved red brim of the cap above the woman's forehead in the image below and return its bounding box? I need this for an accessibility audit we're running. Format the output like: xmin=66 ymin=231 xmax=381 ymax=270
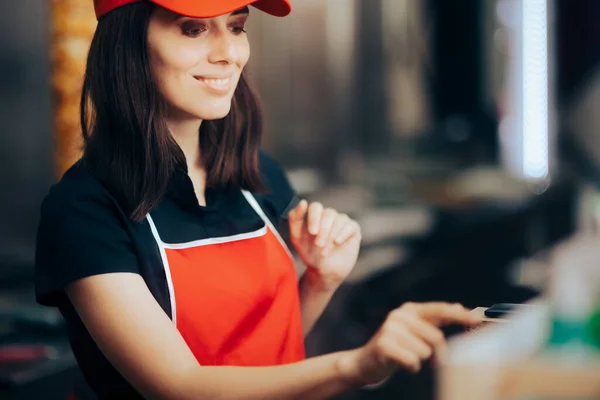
xmin=150 ymin=0 xmax=292 ymax=18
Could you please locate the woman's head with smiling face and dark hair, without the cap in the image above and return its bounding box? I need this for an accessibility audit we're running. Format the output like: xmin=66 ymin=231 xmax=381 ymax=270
xmin=82 ymin=2 xmax=263 ymax=221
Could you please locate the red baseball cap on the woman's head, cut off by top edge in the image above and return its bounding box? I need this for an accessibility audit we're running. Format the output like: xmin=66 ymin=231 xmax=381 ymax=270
xmin=94 ymin=0 xmax=292 ymax=19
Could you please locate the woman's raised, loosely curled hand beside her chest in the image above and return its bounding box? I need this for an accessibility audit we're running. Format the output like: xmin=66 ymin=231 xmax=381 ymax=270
xmin=288 ymin=200 xmax=361 ymax=290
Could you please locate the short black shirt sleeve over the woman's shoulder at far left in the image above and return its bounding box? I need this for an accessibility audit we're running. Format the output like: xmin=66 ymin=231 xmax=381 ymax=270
xmin=35 ymin=163 xmax=138 ymax=305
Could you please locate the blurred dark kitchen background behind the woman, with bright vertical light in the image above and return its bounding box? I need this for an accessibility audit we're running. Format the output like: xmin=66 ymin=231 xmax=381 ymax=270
xmin=0 ymin=0 xmax=600 ymax=399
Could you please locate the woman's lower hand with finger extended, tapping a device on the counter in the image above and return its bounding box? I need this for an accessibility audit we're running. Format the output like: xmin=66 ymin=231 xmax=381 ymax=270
xmin=349 ymin=303 xmax=481 ymax=385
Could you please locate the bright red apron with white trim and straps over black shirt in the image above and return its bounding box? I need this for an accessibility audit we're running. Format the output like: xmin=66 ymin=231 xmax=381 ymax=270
xmin=148 ymin=191 xmax=305 ymax=366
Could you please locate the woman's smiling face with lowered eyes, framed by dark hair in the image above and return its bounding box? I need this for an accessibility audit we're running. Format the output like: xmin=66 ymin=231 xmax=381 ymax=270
xmin=148 ymin=7 xmax=250 ymax=120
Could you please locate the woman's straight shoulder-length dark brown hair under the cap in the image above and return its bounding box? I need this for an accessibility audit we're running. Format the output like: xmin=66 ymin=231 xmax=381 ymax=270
xmin=80 ymin=2 xmax=264 ymax=222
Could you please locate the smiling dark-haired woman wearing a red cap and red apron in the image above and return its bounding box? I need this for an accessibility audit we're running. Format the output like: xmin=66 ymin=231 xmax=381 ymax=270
xmin=36 ymin=0 xmax=477 ymax=400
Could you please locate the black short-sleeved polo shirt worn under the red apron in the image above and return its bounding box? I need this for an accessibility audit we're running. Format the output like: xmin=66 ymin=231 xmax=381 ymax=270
xmin=35 ymin=152 xmax=295 ymax=398
